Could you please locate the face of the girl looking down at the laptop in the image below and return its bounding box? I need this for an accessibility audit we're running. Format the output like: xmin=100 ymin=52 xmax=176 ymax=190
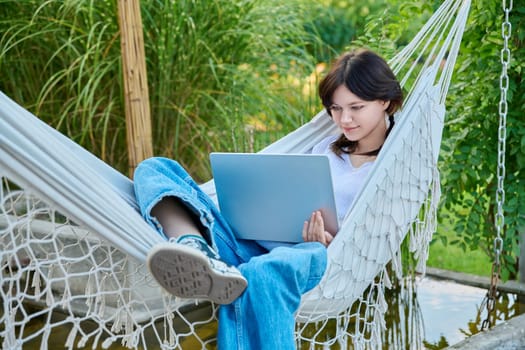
xmin=329 ymin=85 xmax=390 ymax=153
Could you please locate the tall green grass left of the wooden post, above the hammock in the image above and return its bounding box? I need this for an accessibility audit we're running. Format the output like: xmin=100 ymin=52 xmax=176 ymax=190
xmin=0 ymin=1 xmax=125 ymax=164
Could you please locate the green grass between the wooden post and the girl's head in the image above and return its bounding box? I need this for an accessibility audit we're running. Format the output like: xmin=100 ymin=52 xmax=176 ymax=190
xmin=144 ymin=0 xmax=320 ymax=177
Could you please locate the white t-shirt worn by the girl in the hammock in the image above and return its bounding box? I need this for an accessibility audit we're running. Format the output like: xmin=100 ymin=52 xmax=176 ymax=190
xmin=257 ymin=135 xmax=373 ymax=250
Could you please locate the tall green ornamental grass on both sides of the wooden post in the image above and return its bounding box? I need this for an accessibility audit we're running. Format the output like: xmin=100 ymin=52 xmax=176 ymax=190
xmin=0 ymin=0 xmax=320 ymax=180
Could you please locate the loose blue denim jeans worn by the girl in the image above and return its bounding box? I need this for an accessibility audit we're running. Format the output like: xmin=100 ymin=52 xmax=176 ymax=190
xmin=134 ymin=158 xmax=327 ymax=350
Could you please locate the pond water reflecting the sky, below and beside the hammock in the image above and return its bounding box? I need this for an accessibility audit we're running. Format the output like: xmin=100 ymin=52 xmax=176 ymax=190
xmin=0 ymin=278 xmax=525 ymax=350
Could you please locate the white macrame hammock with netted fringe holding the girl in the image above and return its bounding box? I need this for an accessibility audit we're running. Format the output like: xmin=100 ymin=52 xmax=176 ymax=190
xmin=0 ymin=0 xmax=470 ymax=349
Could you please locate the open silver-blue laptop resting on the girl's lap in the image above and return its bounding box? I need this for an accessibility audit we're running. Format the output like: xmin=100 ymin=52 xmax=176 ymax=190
xmin=210 ymin=153 xmax=338 ymax=243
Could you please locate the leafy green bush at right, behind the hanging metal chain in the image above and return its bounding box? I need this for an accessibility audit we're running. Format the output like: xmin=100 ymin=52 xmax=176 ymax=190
xmin=441 ymin=1 xmax=525 ymax=279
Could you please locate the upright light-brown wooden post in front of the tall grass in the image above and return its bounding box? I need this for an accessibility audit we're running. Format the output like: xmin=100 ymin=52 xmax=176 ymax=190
xmin=118 ymin=0 xmax=153 ymax=177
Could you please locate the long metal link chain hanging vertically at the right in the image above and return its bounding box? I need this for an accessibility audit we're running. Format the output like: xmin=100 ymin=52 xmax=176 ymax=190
xmin=481 ymin=0 xmax=512 ymax=330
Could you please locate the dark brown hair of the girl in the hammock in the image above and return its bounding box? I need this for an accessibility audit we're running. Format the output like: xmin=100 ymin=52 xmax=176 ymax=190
xmin=319 ymin=49 xmax=403 ymax=155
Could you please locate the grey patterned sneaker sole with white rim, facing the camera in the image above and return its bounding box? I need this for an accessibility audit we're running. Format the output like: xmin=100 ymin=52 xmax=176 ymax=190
xmin=147 ymin=244 xmax=248 ymax=304
